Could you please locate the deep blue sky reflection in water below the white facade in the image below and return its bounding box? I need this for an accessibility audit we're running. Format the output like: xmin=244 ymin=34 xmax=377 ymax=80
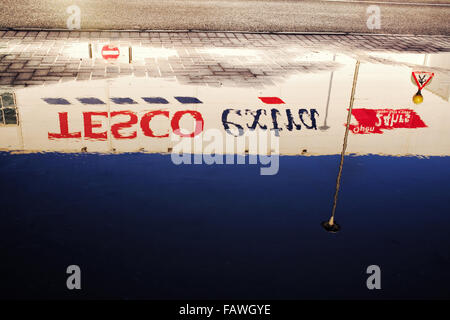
xmin=0 ymin=153 xmax=450 ymax=299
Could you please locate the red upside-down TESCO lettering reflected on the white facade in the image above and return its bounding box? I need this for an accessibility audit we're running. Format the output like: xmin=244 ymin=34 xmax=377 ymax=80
xmin=48 ymin=110 xmax=204 ymax=141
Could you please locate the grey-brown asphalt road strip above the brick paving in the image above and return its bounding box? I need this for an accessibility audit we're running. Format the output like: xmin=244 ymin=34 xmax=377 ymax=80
xmin=0 ymin=0 xmax=450 ymax=35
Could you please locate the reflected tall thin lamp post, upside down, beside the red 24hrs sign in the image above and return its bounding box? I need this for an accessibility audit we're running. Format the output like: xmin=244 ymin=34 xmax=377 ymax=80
xmin=322 ymin=60 xmax=359 ymax=233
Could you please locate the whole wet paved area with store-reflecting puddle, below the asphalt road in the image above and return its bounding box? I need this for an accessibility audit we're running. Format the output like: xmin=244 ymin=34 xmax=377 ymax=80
xmin=0 ymin=31 xmax=450 ymax=299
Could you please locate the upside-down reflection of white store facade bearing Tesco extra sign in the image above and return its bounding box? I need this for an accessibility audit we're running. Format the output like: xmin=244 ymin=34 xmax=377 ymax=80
xmin=0 ymin=53 xmax=450 ymax=156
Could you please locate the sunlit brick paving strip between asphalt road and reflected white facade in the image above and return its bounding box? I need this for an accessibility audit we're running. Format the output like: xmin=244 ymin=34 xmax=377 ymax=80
xmin=0 ymin=30 xmax=450 ymax=87
